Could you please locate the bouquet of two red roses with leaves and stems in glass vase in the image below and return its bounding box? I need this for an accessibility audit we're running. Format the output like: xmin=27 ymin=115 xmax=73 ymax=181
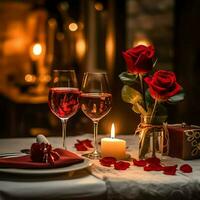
xmin=119 ymin=45 xmax=184 ymax=158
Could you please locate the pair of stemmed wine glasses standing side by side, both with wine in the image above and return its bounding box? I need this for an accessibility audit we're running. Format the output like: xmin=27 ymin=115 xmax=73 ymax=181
xmin=48 ymin=70 xmax=112 ymax=159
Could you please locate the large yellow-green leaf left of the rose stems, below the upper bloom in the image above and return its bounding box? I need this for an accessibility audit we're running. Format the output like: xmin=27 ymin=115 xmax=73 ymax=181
xmin=121 ymin=85 xmax=146 ymax=114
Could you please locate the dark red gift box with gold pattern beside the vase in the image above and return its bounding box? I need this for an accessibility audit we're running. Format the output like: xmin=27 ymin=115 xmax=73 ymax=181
xmin=167 ymin=123 xmax=200 ymax=160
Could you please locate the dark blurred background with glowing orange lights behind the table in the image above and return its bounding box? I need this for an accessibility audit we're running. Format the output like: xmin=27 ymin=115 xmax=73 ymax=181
xmin=0 ymin=0 xmax=200 ymax=137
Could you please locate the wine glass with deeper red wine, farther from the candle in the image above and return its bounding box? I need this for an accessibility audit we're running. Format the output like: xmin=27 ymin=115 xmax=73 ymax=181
xmin=48 ymin=70 xmax=80 ymax=149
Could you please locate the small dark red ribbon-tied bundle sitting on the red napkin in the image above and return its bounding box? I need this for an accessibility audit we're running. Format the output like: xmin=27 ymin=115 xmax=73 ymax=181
xmin=30 ymin=143 xmax=60 ymax=165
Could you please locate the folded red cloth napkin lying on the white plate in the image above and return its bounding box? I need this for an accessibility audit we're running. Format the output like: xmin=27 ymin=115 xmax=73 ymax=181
xmin=0 ymin=148 xmax=84 ymax=169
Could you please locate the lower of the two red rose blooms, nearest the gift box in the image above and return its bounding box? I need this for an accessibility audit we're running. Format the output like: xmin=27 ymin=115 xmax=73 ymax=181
xmin=144 ymin=70 xmax=181 ymax=101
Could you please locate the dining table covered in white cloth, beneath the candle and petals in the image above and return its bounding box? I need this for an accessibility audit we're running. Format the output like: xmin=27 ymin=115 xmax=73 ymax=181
xmin=0 ymin=134 xmax=200 ymax=200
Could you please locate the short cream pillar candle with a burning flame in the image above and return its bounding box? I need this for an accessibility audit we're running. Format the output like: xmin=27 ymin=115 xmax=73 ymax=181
xmin=101 ymin=124 xmax=126 ymax=160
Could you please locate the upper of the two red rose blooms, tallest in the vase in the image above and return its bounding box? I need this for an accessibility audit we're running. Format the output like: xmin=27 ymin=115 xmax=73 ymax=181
xmin=122 ymin=45 xmax=155 ymax=74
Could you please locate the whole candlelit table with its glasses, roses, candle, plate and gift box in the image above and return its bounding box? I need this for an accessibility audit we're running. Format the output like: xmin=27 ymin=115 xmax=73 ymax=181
xmin=0 ymin=45 xmax=200 ymax=200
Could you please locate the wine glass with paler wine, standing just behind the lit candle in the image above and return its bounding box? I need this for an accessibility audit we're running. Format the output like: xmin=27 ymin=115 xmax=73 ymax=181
xmin=80 ymin=72 xmax=112 ymax=159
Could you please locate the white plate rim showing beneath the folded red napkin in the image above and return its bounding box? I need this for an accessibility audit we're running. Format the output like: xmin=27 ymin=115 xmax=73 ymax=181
xmin=0 ymin=159 xmax=92 ymax=175
